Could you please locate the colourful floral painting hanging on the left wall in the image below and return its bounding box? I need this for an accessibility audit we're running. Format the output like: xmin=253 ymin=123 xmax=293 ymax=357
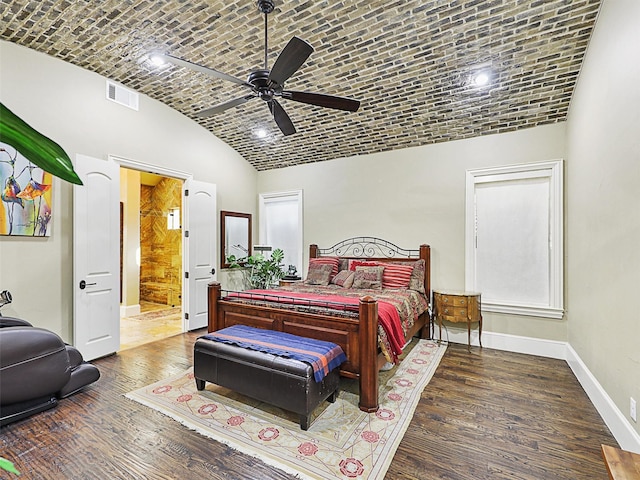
xmin=0 ymin=142 xmax=53 ymax=237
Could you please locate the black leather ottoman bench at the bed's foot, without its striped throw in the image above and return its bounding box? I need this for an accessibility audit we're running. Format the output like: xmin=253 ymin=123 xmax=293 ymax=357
xmin=193 ymin=330 xmax=340 ymax=430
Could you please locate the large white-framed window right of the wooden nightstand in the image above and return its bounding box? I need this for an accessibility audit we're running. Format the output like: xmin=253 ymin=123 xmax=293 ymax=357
xmin=465 ymin=161 xmax=563 ymax=318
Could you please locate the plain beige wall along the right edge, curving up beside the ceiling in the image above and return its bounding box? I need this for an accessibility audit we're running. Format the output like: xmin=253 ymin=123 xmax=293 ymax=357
xmin=566 ymin=0 xmax=640 ymax=432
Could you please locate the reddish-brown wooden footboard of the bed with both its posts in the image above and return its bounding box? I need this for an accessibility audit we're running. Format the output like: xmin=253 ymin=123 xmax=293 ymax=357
xmin=208 ymin=282 xmax=378 ymax=412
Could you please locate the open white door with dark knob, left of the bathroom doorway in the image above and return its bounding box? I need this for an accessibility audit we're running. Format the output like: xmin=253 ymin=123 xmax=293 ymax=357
xmin=73 ymin=155 xmax=120 ymax=360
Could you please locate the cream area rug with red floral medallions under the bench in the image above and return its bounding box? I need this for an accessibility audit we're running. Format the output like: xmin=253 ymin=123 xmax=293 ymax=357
xmin=126 ymin=340 xmax=446 ymax=480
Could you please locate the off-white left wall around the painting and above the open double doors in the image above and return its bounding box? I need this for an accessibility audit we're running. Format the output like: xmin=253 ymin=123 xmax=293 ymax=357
xmin=0 ymin=42 xmax=257 ymax=341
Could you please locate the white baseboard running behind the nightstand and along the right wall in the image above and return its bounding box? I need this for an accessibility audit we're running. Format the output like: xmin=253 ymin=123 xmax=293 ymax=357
xmin=434 ymin=325 xmax=640 ymax=453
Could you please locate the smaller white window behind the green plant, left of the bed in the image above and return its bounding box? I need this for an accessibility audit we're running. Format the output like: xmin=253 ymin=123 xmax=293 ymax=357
xmin=259 ymin=190 xmax=302 ymax=274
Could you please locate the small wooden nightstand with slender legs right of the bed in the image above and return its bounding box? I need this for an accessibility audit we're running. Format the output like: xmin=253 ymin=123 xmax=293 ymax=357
xmin=433 ymin=290 xmax=482 ymax=350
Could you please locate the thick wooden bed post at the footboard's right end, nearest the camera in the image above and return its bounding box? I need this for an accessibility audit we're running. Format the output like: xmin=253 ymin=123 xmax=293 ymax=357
xmin=358 ymin=296 xmax=378 ymax=413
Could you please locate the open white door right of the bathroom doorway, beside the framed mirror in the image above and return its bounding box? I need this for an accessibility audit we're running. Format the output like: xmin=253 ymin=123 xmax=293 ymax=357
xmin=183 ymin=179 xmax=218 ymax=330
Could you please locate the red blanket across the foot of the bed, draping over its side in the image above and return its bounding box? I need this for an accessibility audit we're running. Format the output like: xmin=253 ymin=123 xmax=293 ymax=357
xmin=227 ymin=290 xmax=405 ymax=362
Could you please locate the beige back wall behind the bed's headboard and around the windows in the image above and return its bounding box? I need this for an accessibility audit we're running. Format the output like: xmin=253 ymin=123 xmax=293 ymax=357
xmin=258 ymin=123 xmax=567 ymax=341
